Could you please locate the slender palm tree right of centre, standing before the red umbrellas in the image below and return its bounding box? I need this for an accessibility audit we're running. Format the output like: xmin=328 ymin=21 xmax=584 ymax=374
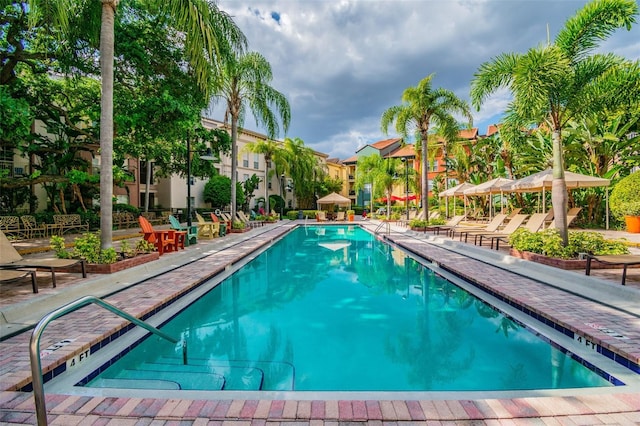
xmin=381 ymin=74 xmax=473 ymax=217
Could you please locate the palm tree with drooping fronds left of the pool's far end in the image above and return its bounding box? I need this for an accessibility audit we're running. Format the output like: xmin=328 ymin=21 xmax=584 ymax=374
xmin=212 ymin=52 xmax=291 ymax=221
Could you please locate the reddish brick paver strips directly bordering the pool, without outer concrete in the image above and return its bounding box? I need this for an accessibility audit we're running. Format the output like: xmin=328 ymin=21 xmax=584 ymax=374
xmin=0 ymin=222 xmax=640 ymax=425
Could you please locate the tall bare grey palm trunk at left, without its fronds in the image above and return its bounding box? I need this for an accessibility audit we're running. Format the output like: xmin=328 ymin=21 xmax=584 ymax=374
xmin=100 ymin=0 xmax=118 ymax=250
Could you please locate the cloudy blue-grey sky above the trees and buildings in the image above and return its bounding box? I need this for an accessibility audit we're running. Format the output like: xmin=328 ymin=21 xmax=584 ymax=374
xmin=213 ymin=0 xmax=640 ymax=159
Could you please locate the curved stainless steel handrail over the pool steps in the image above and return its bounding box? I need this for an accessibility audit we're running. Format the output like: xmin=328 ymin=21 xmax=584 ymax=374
xmin=29 ymin=296 xmax=187 ymax=426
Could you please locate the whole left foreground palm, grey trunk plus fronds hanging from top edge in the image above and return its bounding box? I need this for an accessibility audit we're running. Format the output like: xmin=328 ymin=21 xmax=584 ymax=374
xmin=15 ymin=0 xmax=246 ymax=249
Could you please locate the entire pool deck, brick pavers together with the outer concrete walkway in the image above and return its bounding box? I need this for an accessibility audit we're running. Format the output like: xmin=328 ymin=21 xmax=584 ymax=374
xmin=0 ymin=222 xmax=640 ymax=425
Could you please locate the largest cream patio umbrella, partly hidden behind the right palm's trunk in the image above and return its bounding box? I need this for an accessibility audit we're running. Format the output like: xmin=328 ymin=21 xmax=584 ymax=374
xmin=502 ymin=169 xmax=611 ymax=229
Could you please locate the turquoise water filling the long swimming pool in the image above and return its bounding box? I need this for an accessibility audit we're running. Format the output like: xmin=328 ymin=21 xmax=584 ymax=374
xmin=88 ymin=226 xmax=611 ymax=391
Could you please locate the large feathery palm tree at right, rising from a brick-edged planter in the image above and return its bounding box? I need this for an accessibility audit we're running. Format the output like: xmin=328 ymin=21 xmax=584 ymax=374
xmin=471 ymin=0 xmax=638 ymax=245
